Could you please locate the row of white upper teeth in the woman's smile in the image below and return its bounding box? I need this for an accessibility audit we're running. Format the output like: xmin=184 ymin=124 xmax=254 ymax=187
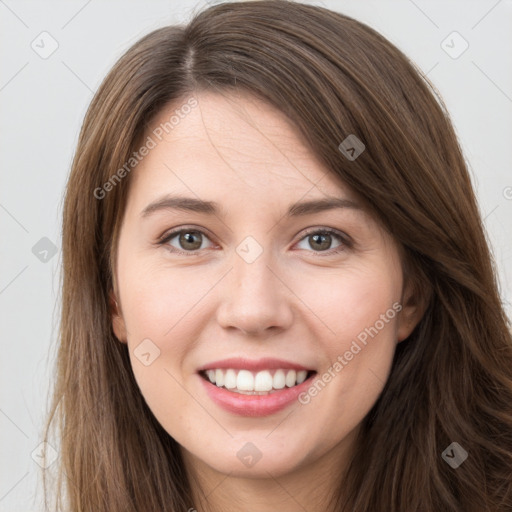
xmin=206 ymin=368 xmax=308 ymax=391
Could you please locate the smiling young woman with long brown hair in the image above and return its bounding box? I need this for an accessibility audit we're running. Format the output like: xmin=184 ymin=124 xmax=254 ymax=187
xmin=43 ymin=0 xmax=512 ymax=512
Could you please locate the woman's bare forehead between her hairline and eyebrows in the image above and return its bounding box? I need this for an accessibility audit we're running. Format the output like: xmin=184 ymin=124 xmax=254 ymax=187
xmin=127 ymin=91 xmax=356 ymax=211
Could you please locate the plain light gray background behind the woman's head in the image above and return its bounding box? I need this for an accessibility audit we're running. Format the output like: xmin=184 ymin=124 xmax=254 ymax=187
xmin=0 ymin=0 xmax=512 ymax=512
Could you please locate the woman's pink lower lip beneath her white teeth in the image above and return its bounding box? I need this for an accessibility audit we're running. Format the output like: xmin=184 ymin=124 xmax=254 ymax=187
xmin=198 ymin=373 xmax=316 ymax=416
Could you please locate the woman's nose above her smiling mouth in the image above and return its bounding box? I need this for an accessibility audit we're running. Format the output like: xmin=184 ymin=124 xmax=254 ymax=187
xmin=217 ymin=252 xmax=294 ymax=337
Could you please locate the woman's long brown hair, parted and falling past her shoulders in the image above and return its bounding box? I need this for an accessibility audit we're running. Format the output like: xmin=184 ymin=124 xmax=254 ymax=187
xmin=46 ymin=0 xmax=512 ymax=512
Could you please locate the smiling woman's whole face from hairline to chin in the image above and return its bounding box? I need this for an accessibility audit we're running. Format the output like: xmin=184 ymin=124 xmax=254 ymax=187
xmin=113 ymin=92 xmax=415 ymax=477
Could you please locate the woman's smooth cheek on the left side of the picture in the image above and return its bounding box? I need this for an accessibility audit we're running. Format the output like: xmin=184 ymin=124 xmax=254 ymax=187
xmin=120 ymin=261 xmax=200 ymax=426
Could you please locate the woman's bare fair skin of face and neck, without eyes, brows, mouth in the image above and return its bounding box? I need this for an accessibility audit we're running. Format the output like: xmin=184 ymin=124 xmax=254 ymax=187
xmin=112 ymin=92 xmax=422 ymax=512
